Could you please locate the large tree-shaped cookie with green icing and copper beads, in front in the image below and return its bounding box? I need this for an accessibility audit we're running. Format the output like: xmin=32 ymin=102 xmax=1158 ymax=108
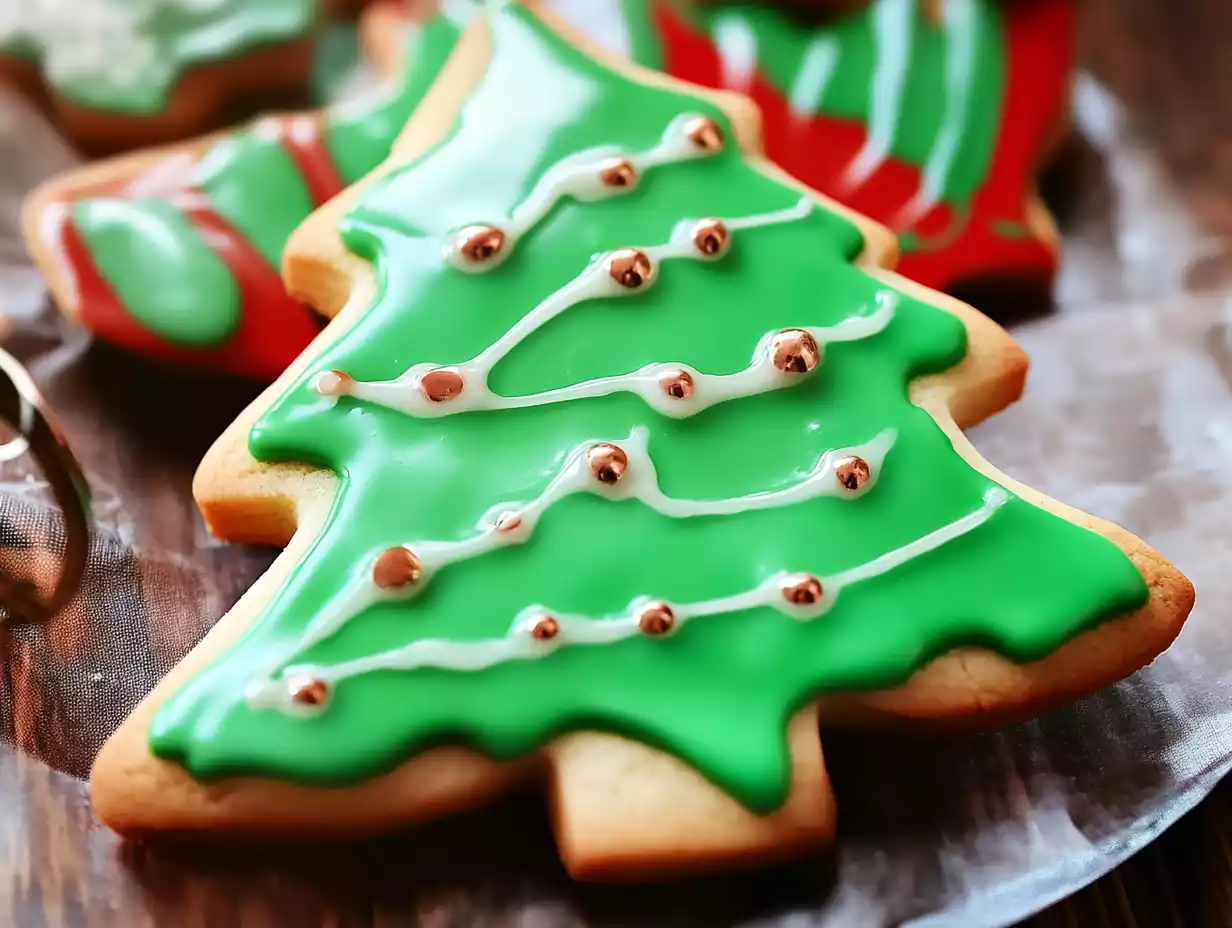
xmin=92 ymin=2 xmax=1193 ymax=879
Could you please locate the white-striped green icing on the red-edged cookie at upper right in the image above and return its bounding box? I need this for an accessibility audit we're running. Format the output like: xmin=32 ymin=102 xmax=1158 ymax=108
xmin=665 ymin=0 xmax=1005 ymax=208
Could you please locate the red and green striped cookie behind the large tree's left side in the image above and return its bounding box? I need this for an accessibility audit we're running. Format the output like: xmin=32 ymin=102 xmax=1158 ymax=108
xmin=23 ymin=2 xmax=460 ymax=381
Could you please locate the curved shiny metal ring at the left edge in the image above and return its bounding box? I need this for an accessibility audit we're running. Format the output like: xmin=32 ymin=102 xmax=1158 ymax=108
xmin=0 ymin=351 xmax=91 ymax=622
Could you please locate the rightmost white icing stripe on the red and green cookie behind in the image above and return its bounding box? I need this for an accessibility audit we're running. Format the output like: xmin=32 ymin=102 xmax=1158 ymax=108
xmin=891 ymin=0 xmax=977 ymax=229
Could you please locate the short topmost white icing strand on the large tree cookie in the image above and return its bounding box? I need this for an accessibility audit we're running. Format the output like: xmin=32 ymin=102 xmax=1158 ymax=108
xmin=442 ymin=113 xmax=716 ymax=274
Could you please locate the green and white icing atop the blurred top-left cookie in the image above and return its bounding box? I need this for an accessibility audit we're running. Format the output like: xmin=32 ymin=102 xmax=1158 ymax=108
xmin=0 ymin=0 xmax=318 ymax=113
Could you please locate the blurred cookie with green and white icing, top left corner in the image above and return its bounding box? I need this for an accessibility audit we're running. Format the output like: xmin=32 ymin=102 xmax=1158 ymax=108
xmin=0 ymin=0 xmax=324 ymax=150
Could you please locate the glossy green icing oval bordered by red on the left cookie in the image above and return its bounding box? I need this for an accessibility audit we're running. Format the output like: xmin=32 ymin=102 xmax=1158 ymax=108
xmin=73 ymin=198 xmax=240 ymax=348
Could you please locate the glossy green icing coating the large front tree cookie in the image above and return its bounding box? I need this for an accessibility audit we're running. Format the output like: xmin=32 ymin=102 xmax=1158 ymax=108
xmin=150 ymin=6 xmax=1147 ymax=812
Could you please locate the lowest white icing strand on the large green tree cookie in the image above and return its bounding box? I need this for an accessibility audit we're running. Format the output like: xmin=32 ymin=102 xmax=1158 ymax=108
xmin=249 ymin=487 xmax=1009 ymax=712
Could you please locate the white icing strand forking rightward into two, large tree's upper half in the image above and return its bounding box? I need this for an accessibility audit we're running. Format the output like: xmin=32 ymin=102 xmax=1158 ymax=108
xmin=346 ymin=197 xmax=897 ymax=419
